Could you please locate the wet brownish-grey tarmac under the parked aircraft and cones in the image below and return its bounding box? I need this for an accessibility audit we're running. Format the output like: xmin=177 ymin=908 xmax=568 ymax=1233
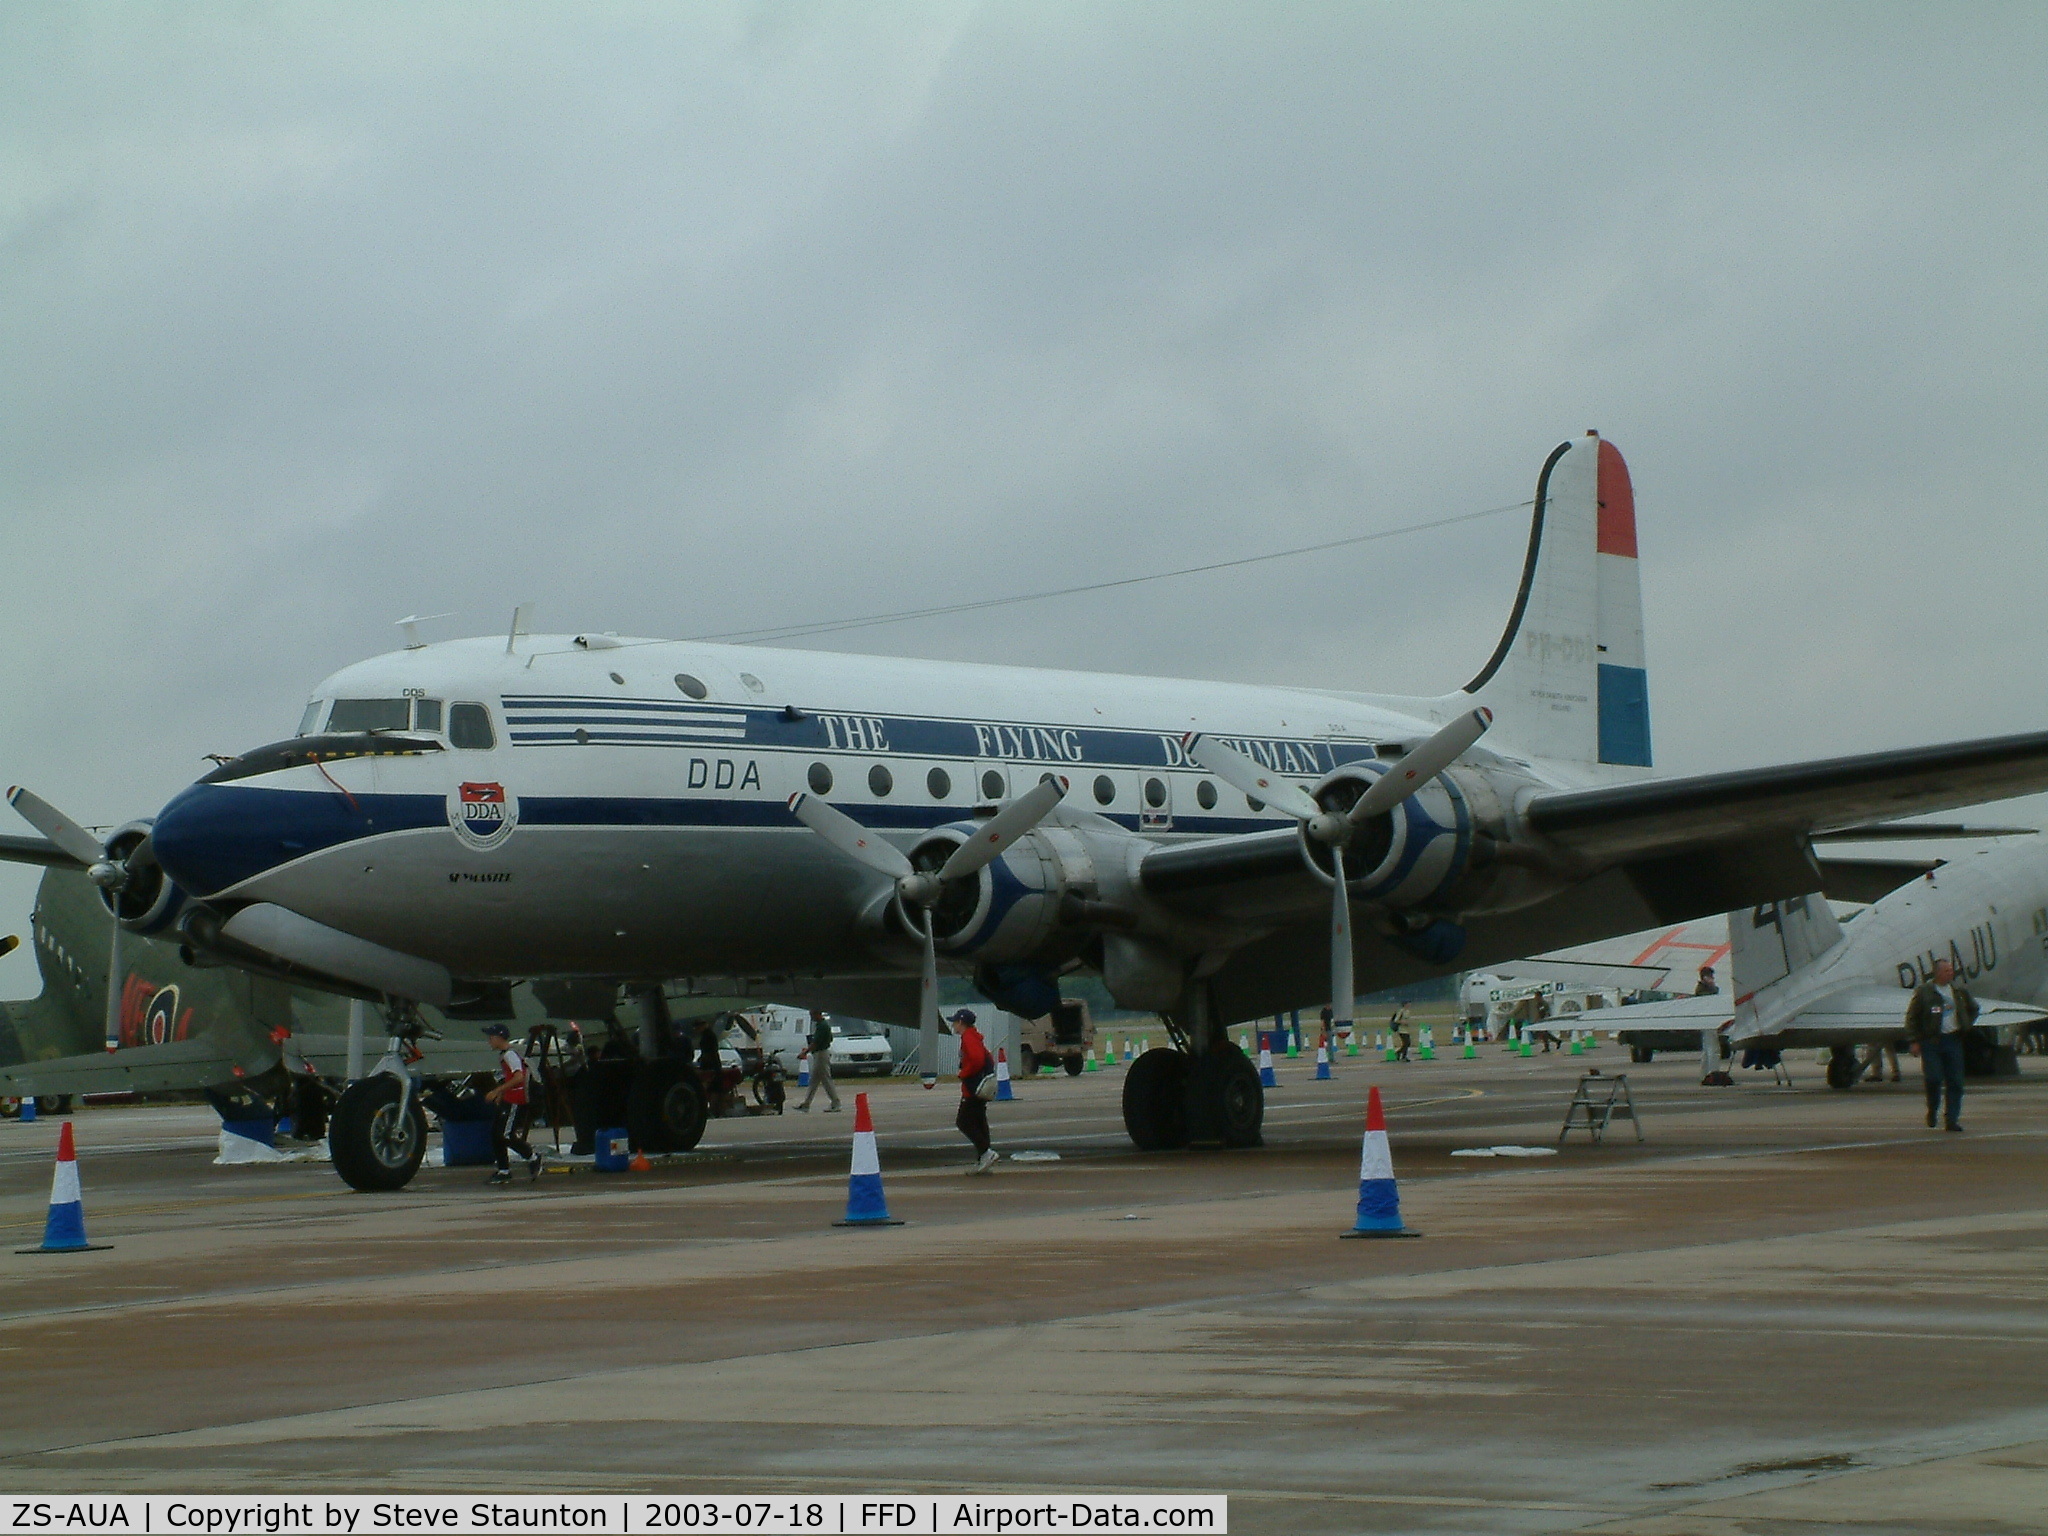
xmin=0 ymin=1047 xmax=2048 ymax=1536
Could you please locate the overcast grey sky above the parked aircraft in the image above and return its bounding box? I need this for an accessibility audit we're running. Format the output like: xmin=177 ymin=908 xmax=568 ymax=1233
xmin=0 ymin=0 xmax=2048 ymax=995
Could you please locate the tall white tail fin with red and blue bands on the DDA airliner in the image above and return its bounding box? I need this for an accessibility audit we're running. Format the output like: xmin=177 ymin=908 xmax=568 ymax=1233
xmin=1464 ymin=432 xmax=1651 ymax=768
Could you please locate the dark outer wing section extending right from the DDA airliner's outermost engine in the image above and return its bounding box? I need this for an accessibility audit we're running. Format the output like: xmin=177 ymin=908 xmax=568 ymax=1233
xmin=1524 ymin=731 xmax=2048 ymax=864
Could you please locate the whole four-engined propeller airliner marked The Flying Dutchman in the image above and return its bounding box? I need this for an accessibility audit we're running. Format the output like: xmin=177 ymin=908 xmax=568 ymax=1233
xmin=0 ymin=434 xmax=2048 ymax=1184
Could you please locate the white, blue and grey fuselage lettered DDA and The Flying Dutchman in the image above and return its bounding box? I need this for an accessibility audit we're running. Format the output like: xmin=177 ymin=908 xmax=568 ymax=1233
xmin=156 ymin=637 xmax=1604 ymax=977
